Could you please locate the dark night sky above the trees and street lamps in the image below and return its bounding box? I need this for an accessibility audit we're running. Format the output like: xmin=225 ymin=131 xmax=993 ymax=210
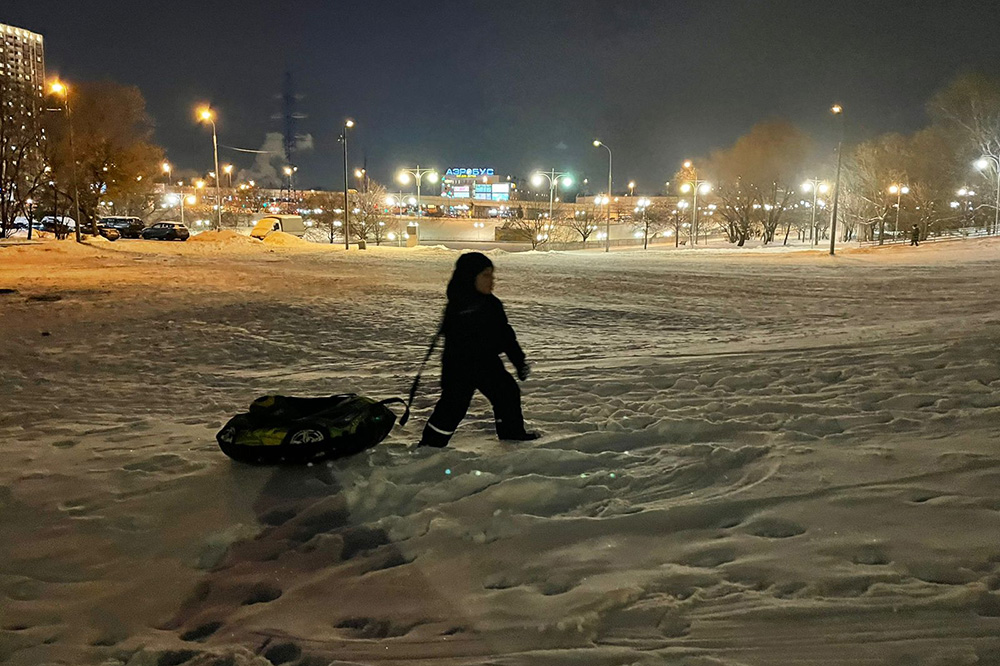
xmin=7 ymin=0 xmax=1000 ymax=192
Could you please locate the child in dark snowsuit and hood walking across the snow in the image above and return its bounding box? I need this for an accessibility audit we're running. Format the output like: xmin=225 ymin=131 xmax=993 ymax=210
xmin=420 ymin=252 xmax=538 ymax=447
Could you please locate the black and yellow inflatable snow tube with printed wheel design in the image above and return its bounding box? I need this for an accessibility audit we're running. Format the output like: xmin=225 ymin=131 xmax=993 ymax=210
xmin=215 ymin=393 xmax=403 ymax=465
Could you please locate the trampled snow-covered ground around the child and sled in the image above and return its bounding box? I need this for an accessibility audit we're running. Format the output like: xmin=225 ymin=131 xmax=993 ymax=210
xmin=0 ymin=236 xmax=1000 ymax=666
